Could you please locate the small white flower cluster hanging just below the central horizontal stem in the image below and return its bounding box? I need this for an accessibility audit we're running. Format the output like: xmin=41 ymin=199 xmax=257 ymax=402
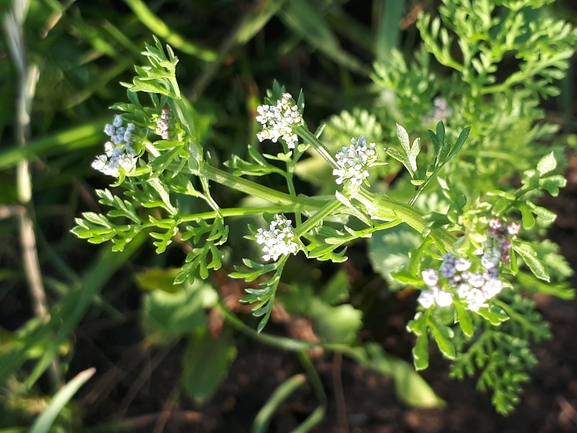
xmin=256 ymin=214 xmax=299 ymax=261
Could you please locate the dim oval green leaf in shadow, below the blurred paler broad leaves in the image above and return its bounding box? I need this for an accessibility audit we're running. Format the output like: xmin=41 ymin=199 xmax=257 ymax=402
xmin=181 ymin=328 xmax=237 ymax=404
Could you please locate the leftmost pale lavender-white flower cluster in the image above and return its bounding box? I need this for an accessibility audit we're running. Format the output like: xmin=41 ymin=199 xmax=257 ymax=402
xmin=92 ymin=114 xmax=138 ymax=177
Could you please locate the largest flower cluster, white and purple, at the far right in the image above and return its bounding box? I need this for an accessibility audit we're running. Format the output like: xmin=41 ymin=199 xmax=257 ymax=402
xmin=417 ymin=218 xmax=520 ymax=311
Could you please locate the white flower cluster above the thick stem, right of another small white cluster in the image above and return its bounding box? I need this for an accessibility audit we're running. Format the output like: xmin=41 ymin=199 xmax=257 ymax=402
xmin=333 ymin=135 xmax=377 ymax=186
